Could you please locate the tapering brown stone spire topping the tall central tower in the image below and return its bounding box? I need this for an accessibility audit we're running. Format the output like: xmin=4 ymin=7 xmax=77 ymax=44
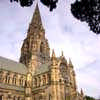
xmin=27 ymin=3 xmax=44 ymax=36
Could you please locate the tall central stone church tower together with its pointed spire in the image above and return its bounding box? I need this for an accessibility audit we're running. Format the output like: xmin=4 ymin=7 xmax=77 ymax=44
xmin=20 ymin=4 xmax=50 ymax=71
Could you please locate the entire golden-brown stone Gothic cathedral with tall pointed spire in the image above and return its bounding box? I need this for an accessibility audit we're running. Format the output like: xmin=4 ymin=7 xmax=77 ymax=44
xmin=0 ymin=4 xmax=84 ymax=100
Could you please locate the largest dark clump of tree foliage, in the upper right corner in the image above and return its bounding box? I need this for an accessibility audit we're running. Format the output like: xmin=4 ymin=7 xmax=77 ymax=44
xmin=71 ymin=0 xmax=100 ymax=34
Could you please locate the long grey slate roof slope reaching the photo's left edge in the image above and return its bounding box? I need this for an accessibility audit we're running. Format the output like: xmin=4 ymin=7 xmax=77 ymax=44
xmin=0 ymin=56 xmax=27 ymax=74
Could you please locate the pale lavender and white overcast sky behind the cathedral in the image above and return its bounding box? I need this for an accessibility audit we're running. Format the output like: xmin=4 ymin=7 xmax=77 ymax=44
xmin=0 ymin=0 xmax=100 ymax=97
